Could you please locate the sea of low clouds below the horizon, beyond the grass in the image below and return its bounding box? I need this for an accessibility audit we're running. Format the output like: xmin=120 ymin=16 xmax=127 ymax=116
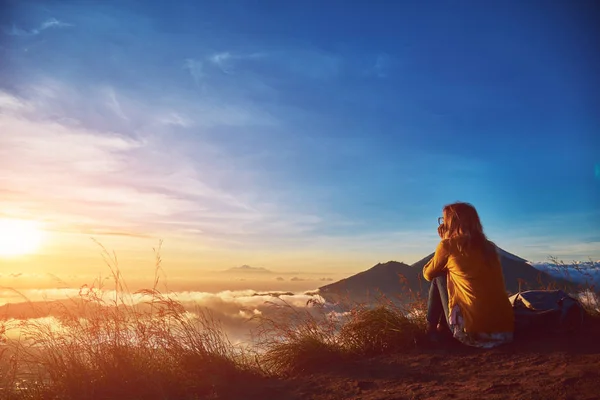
xmin=0 ymin=262 xmax=600 ymax=343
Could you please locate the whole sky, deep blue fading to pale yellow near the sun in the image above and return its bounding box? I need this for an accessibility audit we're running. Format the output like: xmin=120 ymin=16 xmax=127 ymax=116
xmin=0 ymin=0 xmax=600 ymax=277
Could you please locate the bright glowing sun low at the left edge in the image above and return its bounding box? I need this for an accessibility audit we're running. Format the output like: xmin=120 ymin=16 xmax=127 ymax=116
xmin=0 ymin=218 xmax=43 ymax=257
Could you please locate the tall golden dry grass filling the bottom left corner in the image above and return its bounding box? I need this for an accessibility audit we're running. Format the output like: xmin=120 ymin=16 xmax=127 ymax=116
xmin=0 ymin=241 xmax=256 ymax=400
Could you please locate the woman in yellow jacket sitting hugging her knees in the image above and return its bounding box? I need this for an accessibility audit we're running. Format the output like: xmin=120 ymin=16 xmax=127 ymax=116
xmin=423 ymin=203 xmax=514 ymax=348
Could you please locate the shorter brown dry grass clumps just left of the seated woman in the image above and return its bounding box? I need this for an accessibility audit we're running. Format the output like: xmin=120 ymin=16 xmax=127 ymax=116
xmin=255 ymin=288 xmax=425 ymax=376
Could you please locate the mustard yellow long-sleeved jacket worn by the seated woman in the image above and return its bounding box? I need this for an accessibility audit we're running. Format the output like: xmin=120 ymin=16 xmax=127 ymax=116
xmin=423 ymin=238 xmax=514 ymax=333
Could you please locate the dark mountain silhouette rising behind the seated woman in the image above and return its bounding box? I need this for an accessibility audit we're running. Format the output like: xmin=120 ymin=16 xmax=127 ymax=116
xmin=319 ymin=248 xmax=570 ymax=303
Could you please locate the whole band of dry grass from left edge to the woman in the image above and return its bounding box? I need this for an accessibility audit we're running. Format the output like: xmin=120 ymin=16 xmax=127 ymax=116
xmin=0 ymin=244 xmax=600 ymax=400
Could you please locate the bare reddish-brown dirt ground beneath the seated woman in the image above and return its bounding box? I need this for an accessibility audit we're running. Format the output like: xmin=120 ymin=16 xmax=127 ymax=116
xmin=252 ymin=322 xmax=600 ymax=400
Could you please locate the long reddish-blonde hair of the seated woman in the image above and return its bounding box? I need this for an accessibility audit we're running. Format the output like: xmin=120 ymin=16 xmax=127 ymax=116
xmin=443 ymin=202 xmax=497 ymax=259
